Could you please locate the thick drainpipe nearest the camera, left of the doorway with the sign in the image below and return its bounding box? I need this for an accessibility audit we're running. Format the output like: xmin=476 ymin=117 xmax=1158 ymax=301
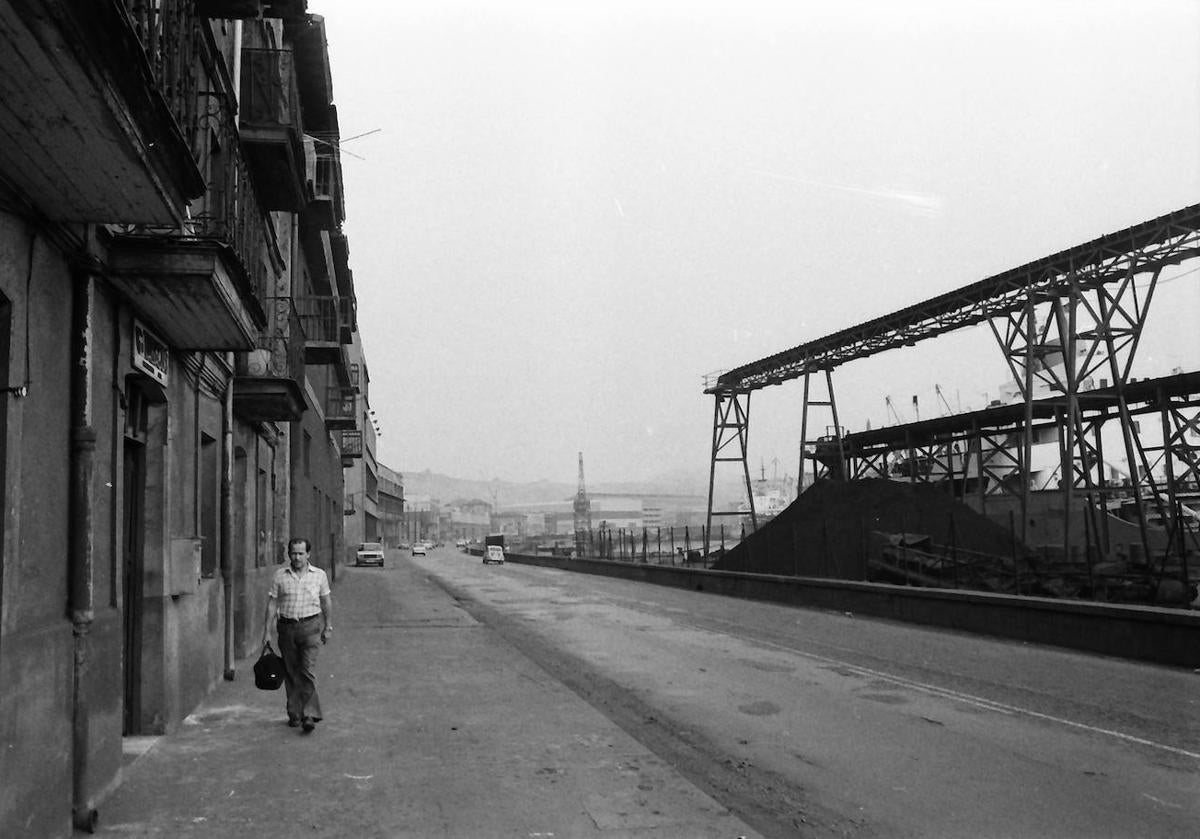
xmin=68 ymin=253 xmax=97 ymax=832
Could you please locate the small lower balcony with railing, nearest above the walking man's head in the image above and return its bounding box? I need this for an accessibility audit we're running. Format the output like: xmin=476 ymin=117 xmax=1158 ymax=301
xmin=233 ymin=298 xmax=306 ymax=423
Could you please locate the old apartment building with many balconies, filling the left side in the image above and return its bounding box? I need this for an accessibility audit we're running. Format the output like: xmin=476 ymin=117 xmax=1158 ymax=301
xmin=0 ymin=0 xmax=364 ymax=837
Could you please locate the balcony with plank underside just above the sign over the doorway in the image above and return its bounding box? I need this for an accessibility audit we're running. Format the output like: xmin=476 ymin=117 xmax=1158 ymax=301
xmin=108 ymin=108 xmax=276 ymax=350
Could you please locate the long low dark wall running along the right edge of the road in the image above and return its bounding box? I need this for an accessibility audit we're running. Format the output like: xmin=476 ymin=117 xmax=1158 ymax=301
xmin=505 ymin=553 xmax=1200 ymax=667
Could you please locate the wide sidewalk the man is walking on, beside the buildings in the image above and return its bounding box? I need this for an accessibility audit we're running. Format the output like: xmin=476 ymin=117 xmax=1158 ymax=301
xmin=91 ymin=551 xmax=757 ymax=839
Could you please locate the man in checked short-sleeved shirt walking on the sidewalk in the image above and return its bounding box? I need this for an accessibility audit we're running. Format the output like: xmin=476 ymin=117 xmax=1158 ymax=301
xmin=263 ymin=539 xmax=334 ymax=733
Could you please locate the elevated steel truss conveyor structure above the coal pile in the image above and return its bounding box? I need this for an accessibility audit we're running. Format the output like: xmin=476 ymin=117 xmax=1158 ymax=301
xmin=706 ymin=204 xmax=1200 ymax=588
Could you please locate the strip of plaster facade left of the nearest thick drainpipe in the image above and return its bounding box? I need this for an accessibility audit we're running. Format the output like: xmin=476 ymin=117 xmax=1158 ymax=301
xmin=0 ymin=211 xmax=74 ymax=835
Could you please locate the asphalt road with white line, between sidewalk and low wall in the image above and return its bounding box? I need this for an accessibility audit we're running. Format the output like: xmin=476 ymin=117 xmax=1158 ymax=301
xmin=412 ymin=549 xmax=1200 ymax=838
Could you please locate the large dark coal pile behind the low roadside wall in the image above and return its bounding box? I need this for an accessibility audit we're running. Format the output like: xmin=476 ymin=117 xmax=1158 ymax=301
xmin=713 ymin=479 xmax=1025 ymax=580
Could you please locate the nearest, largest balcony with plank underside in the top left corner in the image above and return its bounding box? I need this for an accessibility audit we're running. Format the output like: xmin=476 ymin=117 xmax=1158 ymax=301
xmin=0 ymin=0 xmax=204 ymax=224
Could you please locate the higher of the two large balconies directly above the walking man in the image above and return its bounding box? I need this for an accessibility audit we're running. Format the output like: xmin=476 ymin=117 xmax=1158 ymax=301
xmin=240 ymin=48 xmax=307 ymax=212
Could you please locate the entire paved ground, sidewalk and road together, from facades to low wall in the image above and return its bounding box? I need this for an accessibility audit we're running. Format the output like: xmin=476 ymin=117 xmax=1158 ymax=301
xmin=87 ymin=549 xmax=1200 ymax=839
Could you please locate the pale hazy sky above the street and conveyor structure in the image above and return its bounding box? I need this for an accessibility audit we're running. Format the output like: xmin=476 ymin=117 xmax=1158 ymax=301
xmin=310 ymin=0 xmax=1200 ymax=483
